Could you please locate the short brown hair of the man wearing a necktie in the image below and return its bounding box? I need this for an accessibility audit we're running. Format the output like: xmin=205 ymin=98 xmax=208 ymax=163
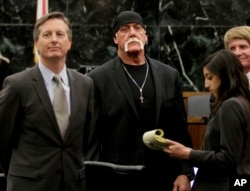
xmin=33 ymin=11 xmax=73 ymax=41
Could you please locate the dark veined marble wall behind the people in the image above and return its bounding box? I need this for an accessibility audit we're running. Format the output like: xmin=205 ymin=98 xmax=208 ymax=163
xmin=0 ymin=0 xmax=250 ymax=91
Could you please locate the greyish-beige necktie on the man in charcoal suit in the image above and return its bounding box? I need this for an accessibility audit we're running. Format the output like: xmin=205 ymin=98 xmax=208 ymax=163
xmin=53 ymin=75 xmax=69 ymax=138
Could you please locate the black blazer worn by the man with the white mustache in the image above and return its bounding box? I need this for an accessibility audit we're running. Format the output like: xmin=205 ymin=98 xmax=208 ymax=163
xmin=88 ymin=57 xmax=191 ymax=190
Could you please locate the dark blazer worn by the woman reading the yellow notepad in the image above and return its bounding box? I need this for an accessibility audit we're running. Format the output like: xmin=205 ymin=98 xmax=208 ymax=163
xmin=190 ymin=97 xmax=250 ymax=191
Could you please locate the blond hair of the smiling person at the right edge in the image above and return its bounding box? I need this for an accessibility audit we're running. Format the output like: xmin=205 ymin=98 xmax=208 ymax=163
xmin=224 ymin=26 xmax=250 ymax=49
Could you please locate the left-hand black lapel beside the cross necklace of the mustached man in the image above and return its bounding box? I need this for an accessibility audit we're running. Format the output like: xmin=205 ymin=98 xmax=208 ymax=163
xmin=112 ymin=57 xmax=139 ymax=118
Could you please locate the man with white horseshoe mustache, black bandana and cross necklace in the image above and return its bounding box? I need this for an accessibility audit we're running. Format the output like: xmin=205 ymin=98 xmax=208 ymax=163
xmin=88 ymin=11 xmax=193 ymax=191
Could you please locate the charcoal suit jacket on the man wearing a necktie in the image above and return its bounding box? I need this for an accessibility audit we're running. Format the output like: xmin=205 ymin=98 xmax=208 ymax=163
xmin=0 ymin=66 xmax=93 ymax=191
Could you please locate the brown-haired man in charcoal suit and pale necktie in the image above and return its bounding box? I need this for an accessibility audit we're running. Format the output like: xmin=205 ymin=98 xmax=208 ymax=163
xmin=0 ymin=12 xmax=93 ymax=191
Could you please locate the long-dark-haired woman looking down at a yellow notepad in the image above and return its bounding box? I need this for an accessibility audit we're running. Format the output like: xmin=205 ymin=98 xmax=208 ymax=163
xmin=164 ymin=50 xmax=250 ymax=191
